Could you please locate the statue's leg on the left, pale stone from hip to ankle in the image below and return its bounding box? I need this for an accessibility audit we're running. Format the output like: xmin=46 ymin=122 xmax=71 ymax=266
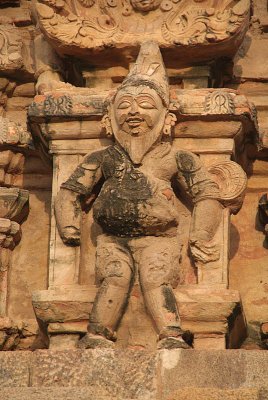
xmin=84 ymin=235 xmax=134 ymax=347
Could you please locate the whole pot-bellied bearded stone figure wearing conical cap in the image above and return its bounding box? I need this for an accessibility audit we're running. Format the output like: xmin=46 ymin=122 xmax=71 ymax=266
xmin=56 ymin=42 xmax=222 ymax=348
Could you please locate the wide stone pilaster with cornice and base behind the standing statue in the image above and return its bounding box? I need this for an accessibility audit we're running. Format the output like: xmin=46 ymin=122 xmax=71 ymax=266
xmin=29 ymin=80 xmax=257 ymax=349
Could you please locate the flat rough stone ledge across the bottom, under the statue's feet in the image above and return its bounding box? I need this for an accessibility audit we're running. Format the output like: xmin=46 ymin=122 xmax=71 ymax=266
xmin=0 ymin=349 xmax=268 ymax=400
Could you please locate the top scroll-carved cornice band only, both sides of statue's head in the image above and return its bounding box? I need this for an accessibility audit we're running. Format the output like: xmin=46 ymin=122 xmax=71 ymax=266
xmin=28 ymin=88 xmax=257 ymax=129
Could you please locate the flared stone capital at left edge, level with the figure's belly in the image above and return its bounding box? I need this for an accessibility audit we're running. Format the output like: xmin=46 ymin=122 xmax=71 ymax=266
xmin=0 ymin=187 xmax=29 ymax=222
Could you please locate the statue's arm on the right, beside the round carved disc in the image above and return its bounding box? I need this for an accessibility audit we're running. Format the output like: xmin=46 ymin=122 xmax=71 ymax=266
xmin=176 ymin=151 xmax=223 ymax=263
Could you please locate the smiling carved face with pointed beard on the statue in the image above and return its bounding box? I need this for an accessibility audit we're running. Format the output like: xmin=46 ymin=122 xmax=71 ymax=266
xmin=111 ymin=86 xmax=167 ymax=164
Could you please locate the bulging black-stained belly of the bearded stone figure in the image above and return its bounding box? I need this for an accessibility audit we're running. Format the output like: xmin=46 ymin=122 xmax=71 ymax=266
xmin=93 ymin=182 xmax=178 ymax=237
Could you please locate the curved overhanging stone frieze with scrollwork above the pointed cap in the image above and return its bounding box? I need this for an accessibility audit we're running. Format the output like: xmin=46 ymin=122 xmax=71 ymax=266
xmin=36 ymin=0 xmax=250 ymax=65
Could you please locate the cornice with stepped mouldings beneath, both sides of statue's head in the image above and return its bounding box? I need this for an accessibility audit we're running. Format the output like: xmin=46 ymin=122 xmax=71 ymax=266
xmin=28 ymin=88 xmax=259 ymax=169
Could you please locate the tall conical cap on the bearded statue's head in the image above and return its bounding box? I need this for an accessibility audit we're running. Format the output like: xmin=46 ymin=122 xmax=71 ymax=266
xmin=119 ymin=41 xmax=169 ymax=107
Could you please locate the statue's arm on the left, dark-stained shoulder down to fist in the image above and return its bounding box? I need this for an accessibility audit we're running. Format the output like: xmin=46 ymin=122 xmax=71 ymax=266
xmin=55 ymin=151 xmax=103 ymax=246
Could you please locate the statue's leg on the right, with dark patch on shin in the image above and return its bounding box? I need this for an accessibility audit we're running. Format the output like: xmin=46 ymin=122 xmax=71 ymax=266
xmin=132 ymin=237 xmax=191 ymax=348
